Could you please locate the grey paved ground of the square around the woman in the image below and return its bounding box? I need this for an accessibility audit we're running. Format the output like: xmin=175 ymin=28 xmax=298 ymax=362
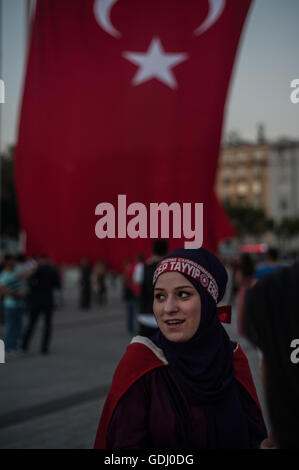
xmin=0 ymin=273 xmax=268 ymax=449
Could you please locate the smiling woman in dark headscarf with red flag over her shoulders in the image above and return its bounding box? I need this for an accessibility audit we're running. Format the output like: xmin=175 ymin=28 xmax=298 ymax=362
xmin=95 ymin=248 xmax=266 ymax=449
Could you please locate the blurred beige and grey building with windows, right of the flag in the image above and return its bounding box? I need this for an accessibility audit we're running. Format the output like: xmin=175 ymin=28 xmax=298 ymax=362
xmin=216 ymin=139 xmax=299 ymax=222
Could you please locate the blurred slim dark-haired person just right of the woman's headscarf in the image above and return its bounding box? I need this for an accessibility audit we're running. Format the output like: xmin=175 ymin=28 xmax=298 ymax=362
xmin=235 ymin=253 xmax=257 ymax=336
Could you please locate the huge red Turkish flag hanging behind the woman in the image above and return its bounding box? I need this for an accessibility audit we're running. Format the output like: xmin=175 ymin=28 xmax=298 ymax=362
xmin=15 ymin=0 xmax=251 ymax=267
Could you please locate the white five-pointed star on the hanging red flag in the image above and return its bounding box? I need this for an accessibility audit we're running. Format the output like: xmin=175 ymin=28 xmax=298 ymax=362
xmin=123 ymin=38 xmax=188 ymax=89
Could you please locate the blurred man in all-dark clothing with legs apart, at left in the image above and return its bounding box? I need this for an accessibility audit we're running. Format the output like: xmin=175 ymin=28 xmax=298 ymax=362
xmin=22 ymin=255 xmax=61 ymax=354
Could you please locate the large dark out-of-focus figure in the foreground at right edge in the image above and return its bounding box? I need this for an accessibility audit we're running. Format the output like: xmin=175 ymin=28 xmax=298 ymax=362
xmin=243 ymin=264 xmax=299 ymax=449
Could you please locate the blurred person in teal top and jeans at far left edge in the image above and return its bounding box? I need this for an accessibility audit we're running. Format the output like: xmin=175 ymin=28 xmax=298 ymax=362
xmin=0 ymin=255 xmax=36 ymax=357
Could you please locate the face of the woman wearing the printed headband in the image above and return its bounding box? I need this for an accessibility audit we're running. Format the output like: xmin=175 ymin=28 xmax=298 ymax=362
xmin=153 ymin=272 xmax=201 ymax=343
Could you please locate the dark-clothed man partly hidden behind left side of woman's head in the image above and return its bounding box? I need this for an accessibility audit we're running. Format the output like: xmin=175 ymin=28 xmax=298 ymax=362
xmin=138 ymin=239 xmax=168 ymax=338
